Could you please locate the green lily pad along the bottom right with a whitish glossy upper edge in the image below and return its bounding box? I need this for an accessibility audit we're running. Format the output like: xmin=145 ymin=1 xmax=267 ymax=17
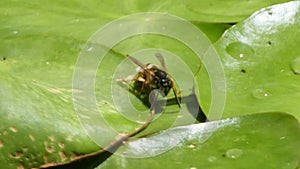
xmin=97 ymin=113 xmax=300 ymax=169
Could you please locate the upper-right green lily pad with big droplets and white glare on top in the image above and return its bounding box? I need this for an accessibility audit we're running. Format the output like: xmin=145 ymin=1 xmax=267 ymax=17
xmin=198 ymin=1 xmax=300 ymax=119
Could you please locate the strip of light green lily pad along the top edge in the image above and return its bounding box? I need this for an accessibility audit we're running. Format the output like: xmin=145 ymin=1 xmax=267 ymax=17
xmin=121 ymin=0 xmax=287 ymax=23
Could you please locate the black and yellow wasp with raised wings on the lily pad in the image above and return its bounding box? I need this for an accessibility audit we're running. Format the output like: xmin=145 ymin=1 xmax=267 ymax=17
xmin=127 ymin=53 xmax=181 ymax=108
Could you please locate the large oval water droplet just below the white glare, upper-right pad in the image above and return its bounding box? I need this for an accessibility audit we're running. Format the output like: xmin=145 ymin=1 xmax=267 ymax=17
xmin=226 ymin=42 xmax=254 ymax=60
